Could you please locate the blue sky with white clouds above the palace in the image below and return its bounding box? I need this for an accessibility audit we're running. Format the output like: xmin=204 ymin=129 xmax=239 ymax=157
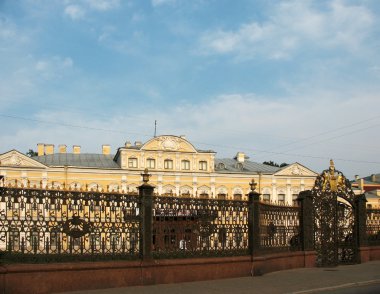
xmin=0 ymin=0 xmax=380 ymax=179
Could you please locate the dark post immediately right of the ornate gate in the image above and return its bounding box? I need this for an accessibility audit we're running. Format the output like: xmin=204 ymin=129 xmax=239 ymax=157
xmin=355 ymin=194 xmax=368 ymax=262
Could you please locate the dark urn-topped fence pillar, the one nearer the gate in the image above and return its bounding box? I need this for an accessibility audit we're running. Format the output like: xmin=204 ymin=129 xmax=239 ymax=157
xmin=248 ymin=179 xmax=260 ymax=256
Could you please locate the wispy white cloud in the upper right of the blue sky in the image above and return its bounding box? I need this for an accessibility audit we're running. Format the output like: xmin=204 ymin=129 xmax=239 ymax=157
xmin=200 ymin=0 xmax=375 ymax=59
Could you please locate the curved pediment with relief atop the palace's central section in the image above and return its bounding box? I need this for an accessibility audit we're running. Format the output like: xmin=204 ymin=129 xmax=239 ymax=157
xmin=141 ymin=136 xmax=197 ymax=153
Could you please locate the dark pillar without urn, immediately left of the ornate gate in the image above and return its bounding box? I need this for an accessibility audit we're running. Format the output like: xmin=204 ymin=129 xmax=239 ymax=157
xmin=297 ymin=190 xmax=314 ymax=251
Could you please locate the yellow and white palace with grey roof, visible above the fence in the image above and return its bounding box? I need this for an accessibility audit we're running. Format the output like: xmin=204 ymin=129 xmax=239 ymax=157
xmin=0 ymin=135 xmax=318 ymax=205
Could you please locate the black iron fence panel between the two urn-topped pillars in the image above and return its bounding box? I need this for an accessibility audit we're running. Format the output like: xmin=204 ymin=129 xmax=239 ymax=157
xmin=153 ymin=197 xmax=248 ymax=258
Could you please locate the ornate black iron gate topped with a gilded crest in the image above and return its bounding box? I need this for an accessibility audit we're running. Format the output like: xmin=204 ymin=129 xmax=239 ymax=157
xmin=311 ymin=160 xmax=359 ymax=266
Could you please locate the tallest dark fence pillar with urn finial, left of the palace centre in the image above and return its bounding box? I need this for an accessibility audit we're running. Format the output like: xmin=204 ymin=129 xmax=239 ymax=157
xmin=138 ymin=169 xmax=154 ymax=261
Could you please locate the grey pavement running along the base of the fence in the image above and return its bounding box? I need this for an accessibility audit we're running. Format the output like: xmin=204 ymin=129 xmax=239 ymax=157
xmin=60 ymin=261 xmax=380 ymax=294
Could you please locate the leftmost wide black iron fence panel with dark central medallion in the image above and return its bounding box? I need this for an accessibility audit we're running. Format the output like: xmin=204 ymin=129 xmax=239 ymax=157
xmin=0 ymin=187 xmax=140 ymax=262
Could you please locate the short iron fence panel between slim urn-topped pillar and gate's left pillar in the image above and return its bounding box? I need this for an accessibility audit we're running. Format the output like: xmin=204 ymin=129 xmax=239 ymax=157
xmin=259 ymin=203 xmax=301 ymax=252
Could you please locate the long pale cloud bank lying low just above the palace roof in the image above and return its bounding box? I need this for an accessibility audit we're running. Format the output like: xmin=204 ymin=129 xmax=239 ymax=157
xmin=0 ymin=92 xmax=380 ymax=177
